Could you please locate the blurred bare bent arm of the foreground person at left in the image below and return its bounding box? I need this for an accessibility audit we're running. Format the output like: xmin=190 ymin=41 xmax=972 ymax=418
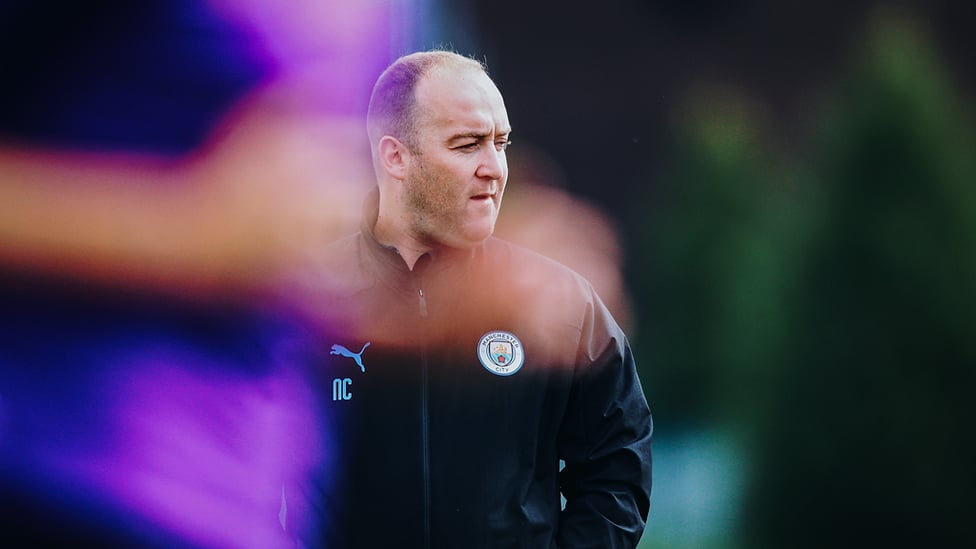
xmin=0 ymin=98 xmax=372 ymax=294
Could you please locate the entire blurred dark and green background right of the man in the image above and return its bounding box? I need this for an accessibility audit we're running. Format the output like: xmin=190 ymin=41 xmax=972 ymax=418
xmin=450 ymin=2 xmax=976 ymax=549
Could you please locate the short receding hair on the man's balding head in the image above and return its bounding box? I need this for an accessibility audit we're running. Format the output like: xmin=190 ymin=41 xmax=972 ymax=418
xmin=366 ymin=51 xmax=487 ymax=154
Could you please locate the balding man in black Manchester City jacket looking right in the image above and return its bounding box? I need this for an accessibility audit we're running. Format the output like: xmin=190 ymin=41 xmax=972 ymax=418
xmin=296 ymin=51 xmax=652 ymax=549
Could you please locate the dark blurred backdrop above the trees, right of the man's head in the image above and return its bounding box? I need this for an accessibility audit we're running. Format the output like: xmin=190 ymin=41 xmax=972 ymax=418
xmin=466 ymin=0 xmax=976 ymax=210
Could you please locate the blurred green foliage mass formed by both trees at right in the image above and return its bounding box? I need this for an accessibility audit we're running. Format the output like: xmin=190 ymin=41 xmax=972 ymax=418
xmin=632 ymin=9 xmax=976 ymax=548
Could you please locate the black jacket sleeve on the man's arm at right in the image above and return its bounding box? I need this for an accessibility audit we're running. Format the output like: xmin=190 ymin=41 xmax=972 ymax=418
xmin=556 ymin=289 xmax=653 ymax=549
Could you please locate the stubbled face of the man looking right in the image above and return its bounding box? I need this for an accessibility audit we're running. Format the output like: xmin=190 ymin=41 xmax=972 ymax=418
xmin=404 ymin=67 xmax=511 ymax=248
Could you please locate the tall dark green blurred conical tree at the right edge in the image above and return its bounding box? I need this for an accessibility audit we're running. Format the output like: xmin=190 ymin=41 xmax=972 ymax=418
xmin=743 ymin=9 xmax=976 ymax=548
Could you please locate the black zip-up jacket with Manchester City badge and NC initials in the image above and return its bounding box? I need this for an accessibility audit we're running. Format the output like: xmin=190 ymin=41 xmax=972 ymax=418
xmin=294 ymin=191 xmax=652 ymax=549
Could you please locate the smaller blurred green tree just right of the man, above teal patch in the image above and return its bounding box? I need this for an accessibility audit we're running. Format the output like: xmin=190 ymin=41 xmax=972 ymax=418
xmin=629 ymin=87 xmax=808 ymax=430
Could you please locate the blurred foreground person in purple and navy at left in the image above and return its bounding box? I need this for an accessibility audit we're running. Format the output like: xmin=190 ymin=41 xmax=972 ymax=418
xmin=0 ymin=1 xmax=380 ymax=547
